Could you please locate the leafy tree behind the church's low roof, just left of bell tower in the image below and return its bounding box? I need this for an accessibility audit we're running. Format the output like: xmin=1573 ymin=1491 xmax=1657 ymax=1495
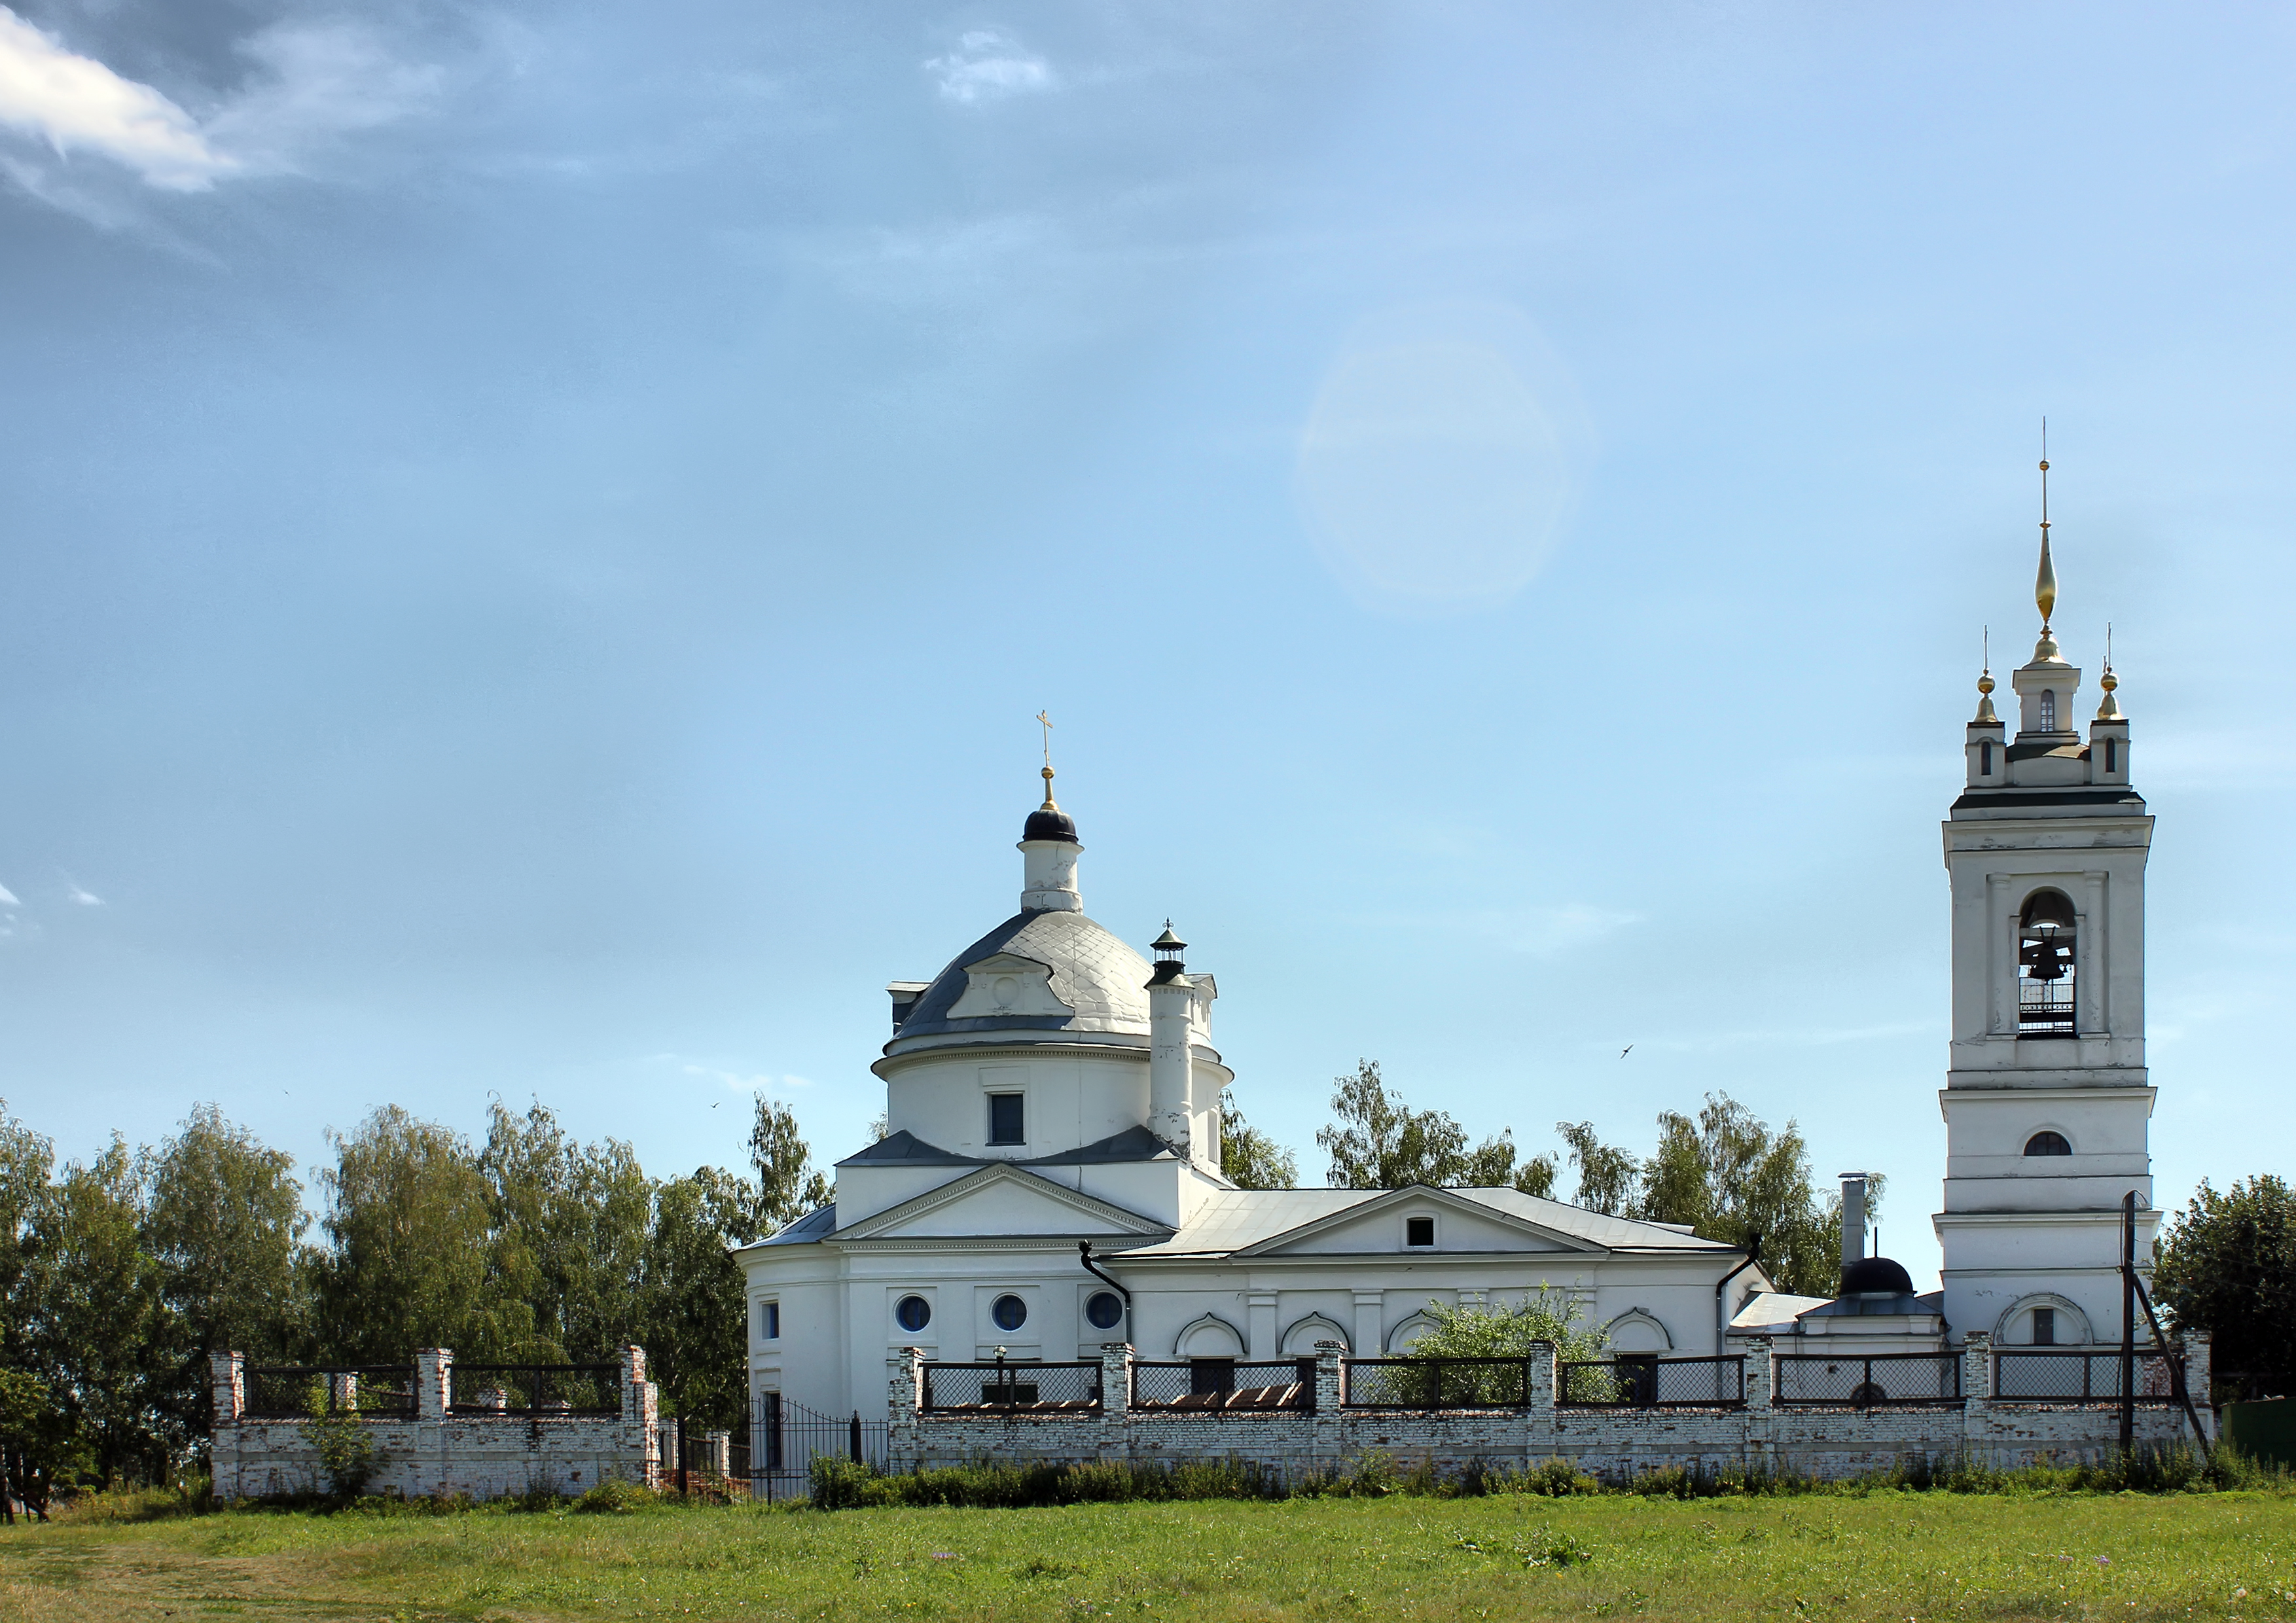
xmin=1634 ymin=1093 xmax=1846 ymax=1297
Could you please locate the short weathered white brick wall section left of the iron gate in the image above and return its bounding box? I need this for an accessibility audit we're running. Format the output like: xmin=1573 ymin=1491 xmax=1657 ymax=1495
xmin=209 ymin=1347 xmax=661 ymax=1499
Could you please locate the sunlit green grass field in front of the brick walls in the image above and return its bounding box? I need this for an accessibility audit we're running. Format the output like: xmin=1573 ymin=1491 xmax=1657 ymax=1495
xmin=0 ymin=1492 xmax=2296 ymax=1620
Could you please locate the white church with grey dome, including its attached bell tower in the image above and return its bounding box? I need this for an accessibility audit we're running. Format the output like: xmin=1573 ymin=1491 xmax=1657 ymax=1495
xmin=735 ymin=530 xmax=2154 ymax=1419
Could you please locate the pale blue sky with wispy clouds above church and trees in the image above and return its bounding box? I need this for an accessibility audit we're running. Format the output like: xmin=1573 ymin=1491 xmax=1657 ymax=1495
xmin=0 ymin=0 xmax=2296 ymax=1274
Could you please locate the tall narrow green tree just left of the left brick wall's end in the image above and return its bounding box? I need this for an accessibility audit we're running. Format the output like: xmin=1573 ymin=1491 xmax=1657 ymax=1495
xmin=23 ymin=1134 xmax=173 ymax=1488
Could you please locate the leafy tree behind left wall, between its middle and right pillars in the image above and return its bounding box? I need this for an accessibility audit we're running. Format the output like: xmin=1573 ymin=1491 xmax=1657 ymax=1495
xmin=478 ymin=1099 xmax=655 ymax=1364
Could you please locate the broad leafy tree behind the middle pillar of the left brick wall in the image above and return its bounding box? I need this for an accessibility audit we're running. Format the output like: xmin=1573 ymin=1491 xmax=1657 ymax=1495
xmin=319 ymin=1104 xmax=542 ymax=1364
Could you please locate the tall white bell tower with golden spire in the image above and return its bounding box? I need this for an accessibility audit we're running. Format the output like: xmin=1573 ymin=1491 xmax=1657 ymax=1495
xmin=1931 ymin=461 xmax=2159 ymax=1346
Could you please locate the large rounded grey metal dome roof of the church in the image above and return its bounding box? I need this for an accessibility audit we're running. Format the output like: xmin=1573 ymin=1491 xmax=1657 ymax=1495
xmin=886 ymin=909 xmax=1151 ymax=1054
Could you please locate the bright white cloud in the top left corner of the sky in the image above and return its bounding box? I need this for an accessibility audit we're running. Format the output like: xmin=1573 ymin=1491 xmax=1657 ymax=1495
xmin=0 ymin=7 xmax=239 ymax=190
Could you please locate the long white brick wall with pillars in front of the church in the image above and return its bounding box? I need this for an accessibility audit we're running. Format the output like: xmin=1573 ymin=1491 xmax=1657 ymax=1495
xmin=889 ymin=1334 xmax=2214 ymax=1481
